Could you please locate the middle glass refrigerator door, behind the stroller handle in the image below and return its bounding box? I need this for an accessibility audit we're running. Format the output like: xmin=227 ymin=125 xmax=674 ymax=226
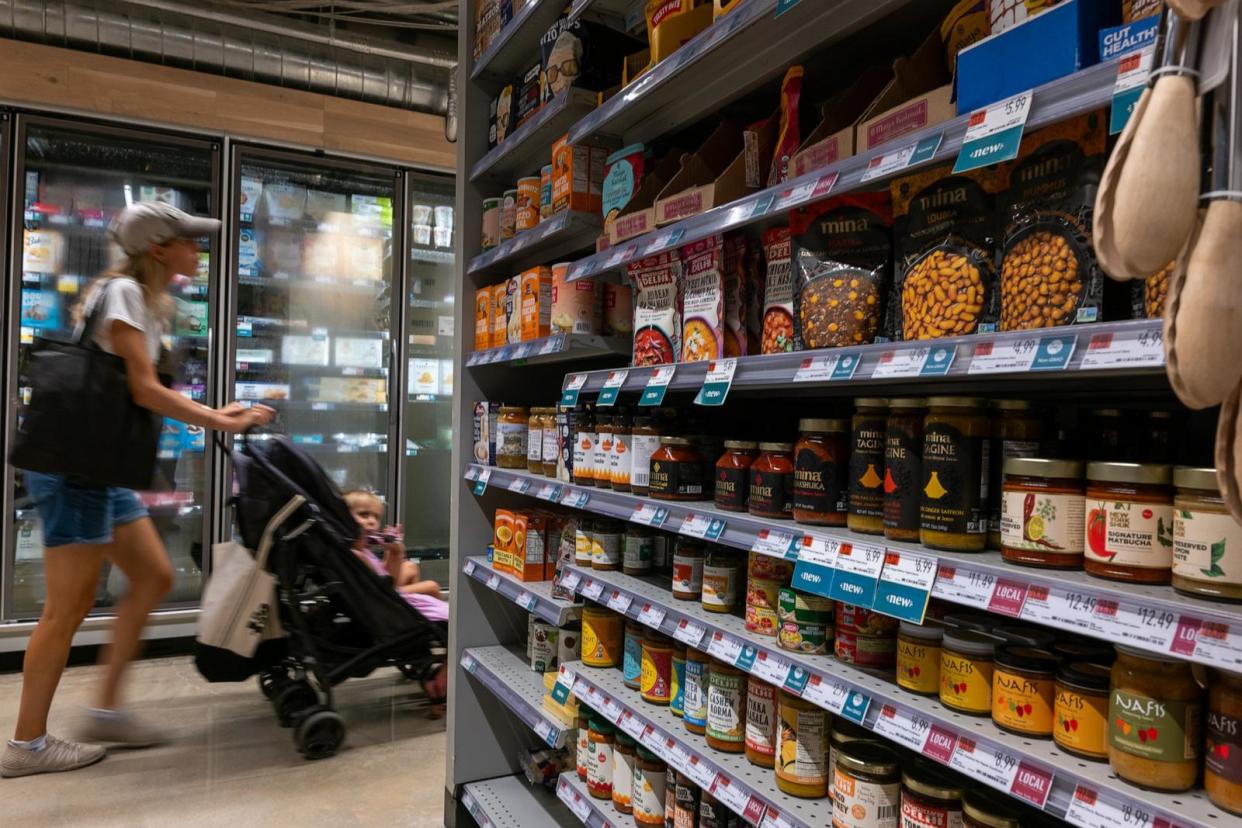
xmin=233 ymin=150 xmax=397 ymax=511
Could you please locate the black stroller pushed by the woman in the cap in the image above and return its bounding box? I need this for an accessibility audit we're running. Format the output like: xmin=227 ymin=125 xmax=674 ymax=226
xmin=195 ymin=434 xmax=447 ymax=758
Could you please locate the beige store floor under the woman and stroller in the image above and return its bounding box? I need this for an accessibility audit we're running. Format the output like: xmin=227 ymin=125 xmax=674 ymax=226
xmin=0 ymin=657 xmax=445 ymax=828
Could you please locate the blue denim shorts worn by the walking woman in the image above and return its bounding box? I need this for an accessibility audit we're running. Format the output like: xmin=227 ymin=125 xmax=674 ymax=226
xmin=22 ymin=472 xmax=147 ymax=546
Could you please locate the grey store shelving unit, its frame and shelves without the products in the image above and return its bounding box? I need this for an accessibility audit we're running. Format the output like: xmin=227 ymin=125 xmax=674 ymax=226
xmin=447 ymin=0 xmax=1242 ymax=826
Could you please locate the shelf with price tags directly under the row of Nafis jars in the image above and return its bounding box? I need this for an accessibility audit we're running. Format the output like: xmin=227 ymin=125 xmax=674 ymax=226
xmin=570 ymin=566 xmax=1233 ymax=826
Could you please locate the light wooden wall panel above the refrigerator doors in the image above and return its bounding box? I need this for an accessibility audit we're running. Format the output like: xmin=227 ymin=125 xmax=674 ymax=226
xmin=0 ymin=38 xmax=457 ymax=170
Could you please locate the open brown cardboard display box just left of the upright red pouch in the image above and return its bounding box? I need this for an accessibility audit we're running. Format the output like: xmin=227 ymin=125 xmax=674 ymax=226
xmin=656 ymin=114 xmax=780 ymax=225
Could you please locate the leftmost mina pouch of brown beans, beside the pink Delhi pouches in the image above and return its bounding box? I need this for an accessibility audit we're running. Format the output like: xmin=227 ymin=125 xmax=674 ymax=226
xmin=790 ymin=192 xmax=893 ymax=350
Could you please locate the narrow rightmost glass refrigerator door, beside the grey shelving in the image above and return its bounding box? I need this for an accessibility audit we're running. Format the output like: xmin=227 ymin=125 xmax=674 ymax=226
xmin=401 ymin=174 xmax=456 ymax=586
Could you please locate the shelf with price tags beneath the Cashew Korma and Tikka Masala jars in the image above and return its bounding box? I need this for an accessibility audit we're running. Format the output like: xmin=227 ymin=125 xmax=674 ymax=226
xmin=569 ymin=662 xmax=832 ymax=828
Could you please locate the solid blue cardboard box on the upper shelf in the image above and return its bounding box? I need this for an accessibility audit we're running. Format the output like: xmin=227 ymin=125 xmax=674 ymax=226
xmin=958 ymin=0 xmax=1122 ymax=114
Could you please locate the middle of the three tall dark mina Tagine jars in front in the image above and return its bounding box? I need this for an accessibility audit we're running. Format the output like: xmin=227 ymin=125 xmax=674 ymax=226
xmin=884 ymin=397 xmax=928 ymax=541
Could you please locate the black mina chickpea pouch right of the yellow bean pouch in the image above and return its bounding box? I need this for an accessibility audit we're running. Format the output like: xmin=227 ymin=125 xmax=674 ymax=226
xmin=1000 ymin=112 xmax=1107 ymax=330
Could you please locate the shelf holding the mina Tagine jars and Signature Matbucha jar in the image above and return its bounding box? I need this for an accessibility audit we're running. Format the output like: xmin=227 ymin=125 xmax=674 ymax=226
xmin=466 ymin=466 xmax=1242 ymax=672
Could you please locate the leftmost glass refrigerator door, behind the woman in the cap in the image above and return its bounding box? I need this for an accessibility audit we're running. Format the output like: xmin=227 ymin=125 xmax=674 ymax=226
xmin=5 ymin=118 xmax=219 ymax=618
